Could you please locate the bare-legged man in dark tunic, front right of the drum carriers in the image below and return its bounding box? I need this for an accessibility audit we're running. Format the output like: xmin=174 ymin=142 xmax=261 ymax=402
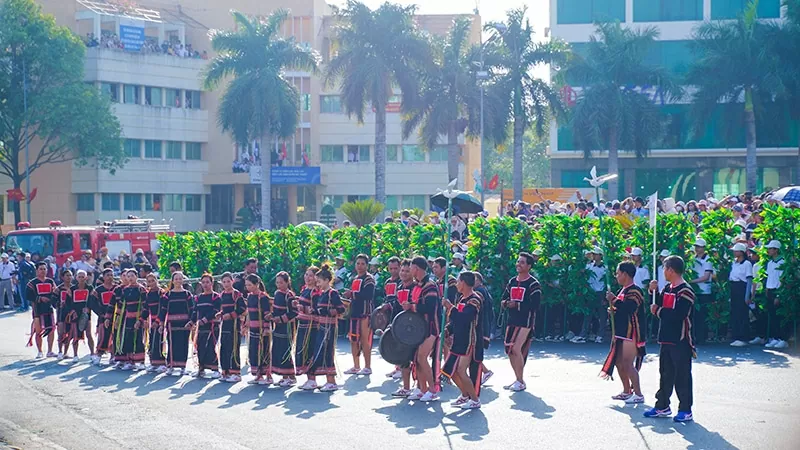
xmin=442 ymin=272 xmax=483 ymax=409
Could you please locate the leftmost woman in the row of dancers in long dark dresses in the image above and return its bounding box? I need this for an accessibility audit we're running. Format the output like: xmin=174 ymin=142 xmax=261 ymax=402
xmin=105 ymin=268 xmax=150 ymax=370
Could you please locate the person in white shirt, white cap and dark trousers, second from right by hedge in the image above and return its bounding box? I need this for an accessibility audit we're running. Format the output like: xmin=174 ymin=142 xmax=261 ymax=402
xmin=728 ymin=243 xmax=753 ymax=347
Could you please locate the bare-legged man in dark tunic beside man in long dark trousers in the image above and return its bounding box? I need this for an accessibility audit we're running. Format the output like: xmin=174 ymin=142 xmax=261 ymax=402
xmin=600 ymin=262 xmax=645 ymax=404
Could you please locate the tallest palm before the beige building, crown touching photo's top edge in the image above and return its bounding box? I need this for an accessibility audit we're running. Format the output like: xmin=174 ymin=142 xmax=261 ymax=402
xmin=325 ymin=0 xmax=431 ymax=204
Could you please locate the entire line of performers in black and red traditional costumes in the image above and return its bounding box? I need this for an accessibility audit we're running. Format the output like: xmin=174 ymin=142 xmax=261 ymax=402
xmin=18 ymin=252 xmax=694 ymax=420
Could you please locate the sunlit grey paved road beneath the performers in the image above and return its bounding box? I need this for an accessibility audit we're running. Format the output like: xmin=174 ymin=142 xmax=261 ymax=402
xmin=0 ymin=313 xmax=800 ymax=450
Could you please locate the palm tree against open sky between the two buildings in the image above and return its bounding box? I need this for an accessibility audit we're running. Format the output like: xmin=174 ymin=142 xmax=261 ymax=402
xmin=485 ymin=8 xmax=567 ymax=200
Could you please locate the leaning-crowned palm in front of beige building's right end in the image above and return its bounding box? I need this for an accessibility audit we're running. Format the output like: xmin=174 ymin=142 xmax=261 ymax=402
xmin=403 ymin=17 xmax=480 ymax=183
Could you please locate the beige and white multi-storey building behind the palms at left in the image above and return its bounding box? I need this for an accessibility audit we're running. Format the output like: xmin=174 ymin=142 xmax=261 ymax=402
xmin=9 ymin=0 xmax=481 ymax=231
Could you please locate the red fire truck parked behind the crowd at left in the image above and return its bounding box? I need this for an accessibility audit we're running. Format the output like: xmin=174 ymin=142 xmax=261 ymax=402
xmin=6 ymin=217 xmax=175 ymax=265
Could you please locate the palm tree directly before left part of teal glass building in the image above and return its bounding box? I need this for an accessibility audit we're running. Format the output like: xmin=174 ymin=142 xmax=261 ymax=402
xmin=565 ymin=22 xmax=680 ymax=198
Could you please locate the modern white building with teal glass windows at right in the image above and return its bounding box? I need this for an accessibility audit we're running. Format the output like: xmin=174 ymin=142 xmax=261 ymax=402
xmin=550 ymin=0 xmax=798 ymax=200
